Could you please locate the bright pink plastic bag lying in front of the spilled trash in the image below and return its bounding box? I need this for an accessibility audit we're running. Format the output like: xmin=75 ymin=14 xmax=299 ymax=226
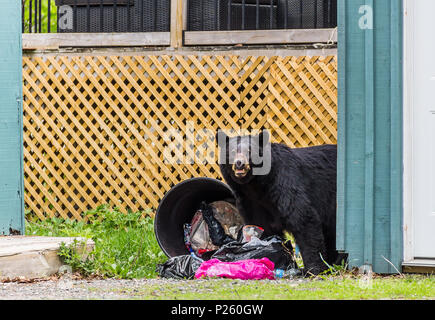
xmin=195 ymin=258 xmax=275 ymax=280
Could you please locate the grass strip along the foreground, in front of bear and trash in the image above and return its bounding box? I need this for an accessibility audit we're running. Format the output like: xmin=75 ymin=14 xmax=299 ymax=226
xmin=84 ymin=275 xmax=435 ymax=300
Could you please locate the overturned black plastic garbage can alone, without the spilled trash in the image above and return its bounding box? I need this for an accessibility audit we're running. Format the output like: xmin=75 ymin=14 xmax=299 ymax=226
xmin=154 ymin=178 xmax=234 ymax=257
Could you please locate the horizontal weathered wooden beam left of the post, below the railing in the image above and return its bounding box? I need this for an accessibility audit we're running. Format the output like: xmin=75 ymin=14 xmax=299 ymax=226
xmin=23 ymin=32 xmax=170 ymax=50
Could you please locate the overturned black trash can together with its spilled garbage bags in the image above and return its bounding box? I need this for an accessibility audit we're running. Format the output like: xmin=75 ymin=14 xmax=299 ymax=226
xmin=154 ymin=178 xmax=301 ymax=279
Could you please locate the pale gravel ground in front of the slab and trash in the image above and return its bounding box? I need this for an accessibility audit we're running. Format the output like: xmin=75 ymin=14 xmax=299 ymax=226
xmin=0 ymin=275 xmax=306 ymax=300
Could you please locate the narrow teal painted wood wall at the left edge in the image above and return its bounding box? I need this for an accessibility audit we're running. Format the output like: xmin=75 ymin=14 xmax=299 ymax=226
xmin=0 ymin=0 xmax=24 ymax=235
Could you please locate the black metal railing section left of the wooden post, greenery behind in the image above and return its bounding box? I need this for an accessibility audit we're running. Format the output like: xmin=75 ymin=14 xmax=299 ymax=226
xmin=22 ymin=0 xmax=170 ymax=33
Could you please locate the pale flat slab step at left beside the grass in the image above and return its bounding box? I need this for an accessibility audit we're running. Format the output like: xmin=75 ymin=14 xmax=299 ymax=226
xmin=0 ymin=236 xmax=94 ymax=279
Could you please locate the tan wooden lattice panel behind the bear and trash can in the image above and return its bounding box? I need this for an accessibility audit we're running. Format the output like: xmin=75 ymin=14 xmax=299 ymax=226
xmin=23 ymin=55 xmax=337 ymax=219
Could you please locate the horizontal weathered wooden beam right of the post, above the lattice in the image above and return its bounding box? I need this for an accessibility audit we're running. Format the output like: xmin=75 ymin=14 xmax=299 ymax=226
xmin=184 ymin=29 xmax=337 ymax=46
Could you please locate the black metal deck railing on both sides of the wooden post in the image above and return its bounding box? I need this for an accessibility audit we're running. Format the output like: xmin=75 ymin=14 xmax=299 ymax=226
xmin=22 ymin=0 xmax=337 ymax=33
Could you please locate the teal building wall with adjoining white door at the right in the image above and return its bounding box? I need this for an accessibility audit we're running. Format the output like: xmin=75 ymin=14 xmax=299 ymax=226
xmin=337 ymin=0 xmax=435 ymax=273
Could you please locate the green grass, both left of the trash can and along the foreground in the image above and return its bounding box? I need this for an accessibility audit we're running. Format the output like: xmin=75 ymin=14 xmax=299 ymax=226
xmin=26 ymin=206 xmax=435 ymax=300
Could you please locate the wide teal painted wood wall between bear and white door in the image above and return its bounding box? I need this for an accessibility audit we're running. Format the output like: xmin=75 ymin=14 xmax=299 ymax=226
xmin=337 ymin=0 xmax=403 ymax=273
